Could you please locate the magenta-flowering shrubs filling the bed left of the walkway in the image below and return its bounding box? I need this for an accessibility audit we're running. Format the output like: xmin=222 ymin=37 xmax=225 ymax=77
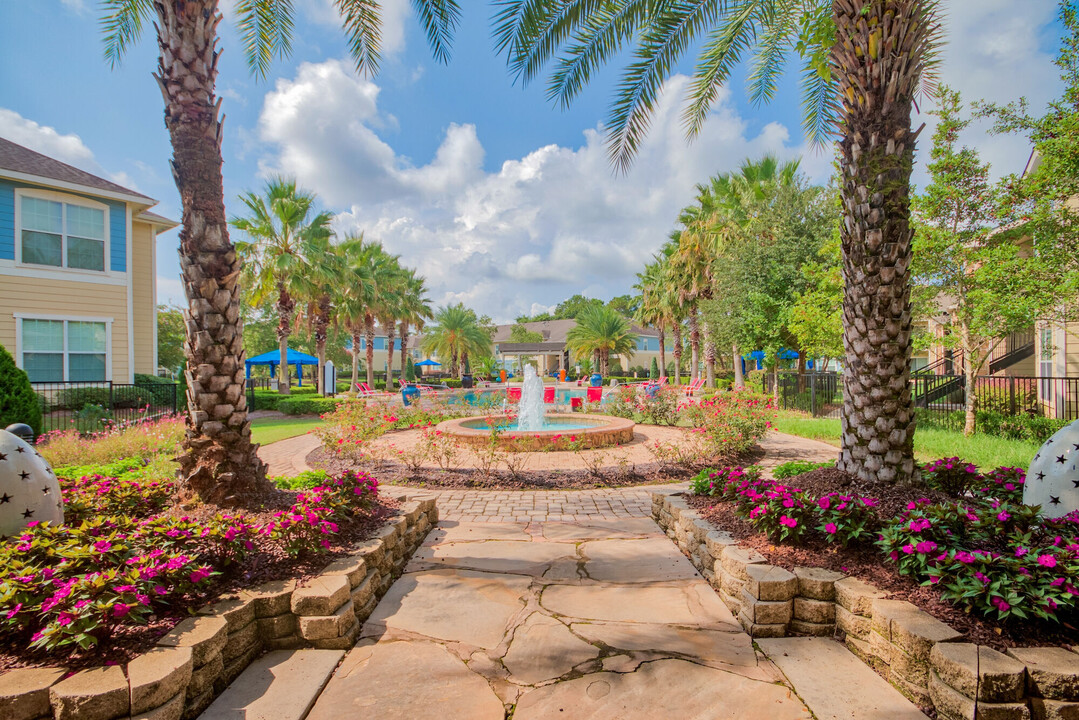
xmin=0 ymin=473 xmax=378 ymax=651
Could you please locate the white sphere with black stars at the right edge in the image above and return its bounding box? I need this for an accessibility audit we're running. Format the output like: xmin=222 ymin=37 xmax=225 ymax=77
xmin=1023 ymin=420 xmax=1079 ymax=517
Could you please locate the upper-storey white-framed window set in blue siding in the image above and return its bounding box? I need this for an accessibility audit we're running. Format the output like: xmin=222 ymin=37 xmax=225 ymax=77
xmin=19 ymin=195 xmax=106 ymax=272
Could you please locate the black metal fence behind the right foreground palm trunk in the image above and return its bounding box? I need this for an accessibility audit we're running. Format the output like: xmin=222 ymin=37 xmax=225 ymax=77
xmin=762 ymin=372 xmax=1079 ymax=430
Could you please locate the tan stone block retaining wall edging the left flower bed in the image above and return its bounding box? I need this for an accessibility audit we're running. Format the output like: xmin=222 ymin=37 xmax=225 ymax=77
xmin=0 ymin=498 xmax=438 ymax=720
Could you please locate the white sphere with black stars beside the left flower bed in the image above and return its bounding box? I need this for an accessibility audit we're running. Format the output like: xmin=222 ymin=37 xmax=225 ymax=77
xmin=0 ymin=430 xmax=64 ymax=539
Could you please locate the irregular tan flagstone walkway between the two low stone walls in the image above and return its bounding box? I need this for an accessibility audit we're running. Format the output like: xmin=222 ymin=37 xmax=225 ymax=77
xmin=309 ymin=518 xmax=811 ymax=720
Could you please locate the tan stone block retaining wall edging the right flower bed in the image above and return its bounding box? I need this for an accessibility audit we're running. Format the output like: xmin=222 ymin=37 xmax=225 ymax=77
xmin=652 ymin=492 xmax=1079 ymax=720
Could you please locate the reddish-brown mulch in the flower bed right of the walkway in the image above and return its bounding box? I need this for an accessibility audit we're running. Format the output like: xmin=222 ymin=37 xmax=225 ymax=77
xmin=685 ymin=496 xmax=1079 ymax=651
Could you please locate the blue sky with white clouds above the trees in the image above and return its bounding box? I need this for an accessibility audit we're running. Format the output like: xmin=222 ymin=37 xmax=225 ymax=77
xmin=0 ymin=0 xmax=1060 ymax=321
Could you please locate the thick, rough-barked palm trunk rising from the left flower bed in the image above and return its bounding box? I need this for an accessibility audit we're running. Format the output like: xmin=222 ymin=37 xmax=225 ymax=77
xmin=154 ymin=0 xmax=272 ymax=505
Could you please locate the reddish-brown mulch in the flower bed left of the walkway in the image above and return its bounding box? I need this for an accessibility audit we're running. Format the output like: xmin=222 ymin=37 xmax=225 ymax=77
xmin=0 ymin=490 xmax=400 ymax=674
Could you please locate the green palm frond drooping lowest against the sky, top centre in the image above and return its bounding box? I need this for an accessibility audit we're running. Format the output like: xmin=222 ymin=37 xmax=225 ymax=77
xmin=607 ymin=0 xmax=727 ymax=172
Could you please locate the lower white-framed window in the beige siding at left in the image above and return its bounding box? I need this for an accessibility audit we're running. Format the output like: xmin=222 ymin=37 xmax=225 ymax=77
xmin=22 ymin=318 xmax=108 ymax=382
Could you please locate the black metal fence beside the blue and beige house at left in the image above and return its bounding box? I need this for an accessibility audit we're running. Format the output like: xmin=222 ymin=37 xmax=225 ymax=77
xmin=30 ymin=380 xmax=180 ymax=433
